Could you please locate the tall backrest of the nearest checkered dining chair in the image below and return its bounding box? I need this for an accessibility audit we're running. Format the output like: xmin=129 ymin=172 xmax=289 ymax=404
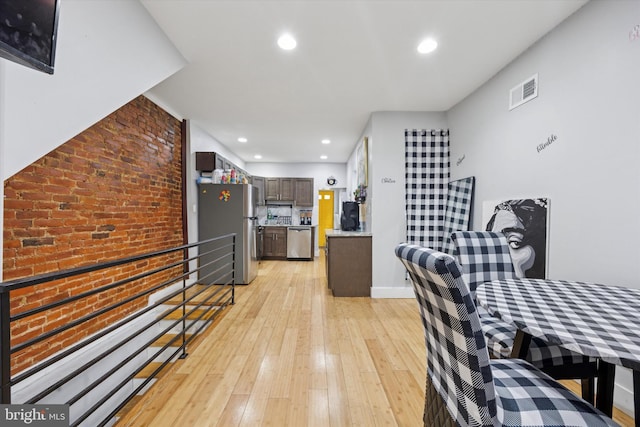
xmin=396 ymin=245 xmax=497 ymax=425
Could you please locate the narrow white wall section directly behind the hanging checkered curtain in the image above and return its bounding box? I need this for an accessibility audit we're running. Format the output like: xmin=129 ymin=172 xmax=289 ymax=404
xmin=367 ymin=112 xmax=448 ymax=298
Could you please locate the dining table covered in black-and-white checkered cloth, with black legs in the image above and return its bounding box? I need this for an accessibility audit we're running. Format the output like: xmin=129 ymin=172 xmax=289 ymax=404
xmin=476 ymin=278 xmax=640 ymax=426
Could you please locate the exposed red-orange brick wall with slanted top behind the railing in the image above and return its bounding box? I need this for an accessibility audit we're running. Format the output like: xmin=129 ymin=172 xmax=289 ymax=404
xmin=3 ymin=96 xmax=183 ymax=371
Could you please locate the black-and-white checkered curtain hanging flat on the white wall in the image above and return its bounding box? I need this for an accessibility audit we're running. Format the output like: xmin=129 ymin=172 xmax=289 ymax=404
xmin=404 ymin=129 xmax=450 ymax=250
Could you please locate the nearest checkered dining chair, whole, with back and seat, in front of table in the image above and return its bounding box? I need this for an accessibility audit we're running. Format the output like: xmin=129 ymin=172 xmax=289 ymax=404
xmin=395 ymin=243 xmax=617 ymax=427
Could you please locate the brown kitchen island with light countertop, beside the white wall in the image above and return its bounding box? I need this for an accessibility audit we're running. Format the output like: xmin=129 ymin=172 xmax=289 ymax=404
xmin=325 ymin=230 xmax=373 ymax=297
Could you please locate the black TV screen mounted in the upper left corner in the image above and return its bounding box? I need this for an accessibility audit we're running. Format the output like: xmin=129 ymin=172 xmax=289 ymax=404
xmin=0 ymin=0 xmax=60 ymax=74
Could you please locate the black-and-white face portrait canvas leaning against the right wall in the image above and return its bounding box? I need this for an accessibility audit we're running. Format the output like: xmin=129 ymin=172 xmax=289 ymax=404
xmin=482 ymin=197 xmax=549 ymax=279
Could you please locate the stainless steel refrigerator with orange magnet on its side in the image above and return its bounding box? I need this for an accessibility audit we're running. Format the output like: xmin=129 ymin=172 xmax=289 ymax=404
xmin=198 ymin=184 xmax=258 ymax=284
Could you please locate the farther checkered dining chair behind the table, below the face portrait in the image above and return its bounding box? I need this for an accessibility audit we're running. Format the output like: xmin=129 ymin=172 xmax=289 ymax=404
xmin=451 ymin=231 xmax=598 ymax=403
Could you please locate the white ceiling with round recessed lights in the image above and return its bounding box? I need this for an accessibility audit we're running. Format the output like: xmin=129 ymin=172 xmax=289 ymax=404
xmin=141 ymin=0 xmax=587 ymax=163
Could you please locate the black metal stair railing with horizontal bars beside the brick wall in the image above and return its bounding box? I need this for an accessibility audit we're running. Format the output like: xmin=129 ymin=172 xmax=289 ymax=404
xmin=0 ymin=234 xmax=236 ymax=426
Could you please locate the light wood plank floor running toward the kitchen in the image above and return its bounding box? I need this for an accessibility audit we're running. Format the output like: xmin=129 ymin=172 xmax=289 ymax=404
xmin=117 ymin=258 xmax=633 ymax=427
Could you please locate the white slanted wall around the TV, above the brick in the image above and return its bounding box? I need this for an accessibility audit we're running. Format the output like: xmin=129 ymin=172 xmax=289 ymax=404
xmin=0 ymin=0 xmax=185 ymax=179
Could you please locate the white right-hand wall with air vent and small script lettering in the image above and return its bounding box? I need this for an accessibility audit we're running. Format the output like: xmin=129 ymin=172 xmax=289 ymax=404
xmin=447 ymin=0 xmax=640 ymax=410
